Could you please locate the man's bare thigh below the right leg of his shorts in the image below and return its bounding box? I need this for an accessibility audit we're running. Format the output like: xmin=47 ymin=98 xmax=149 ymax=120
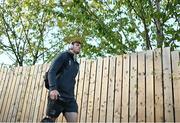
xmin=64 ymin=112 xmax=78 ymax=122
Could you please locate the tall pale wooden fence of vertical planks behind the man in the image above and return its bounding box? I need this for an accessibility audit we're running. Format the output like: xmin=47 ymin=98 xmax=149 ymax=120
xmin=0 ymin=48 xmax=180 ymax=122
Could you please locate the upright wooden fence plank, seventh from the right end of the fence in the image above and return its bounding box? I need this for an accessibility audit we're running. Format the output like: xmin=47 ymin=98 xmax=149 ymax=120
xmin=121 ymin=54 xmax=130 ymax=122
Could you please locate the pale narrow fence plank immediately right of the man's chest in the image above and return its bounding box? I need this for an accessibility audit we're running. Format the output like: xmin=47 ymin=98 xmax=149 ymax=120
xmin=77 ymin=59 xmax=86 ymax=121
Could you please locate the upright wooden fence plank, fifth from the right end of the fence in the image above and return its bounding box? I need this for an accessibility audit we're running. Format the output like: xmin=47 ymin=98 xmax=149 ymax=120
xmin=138 ymin=52 xmax=146 ymax=122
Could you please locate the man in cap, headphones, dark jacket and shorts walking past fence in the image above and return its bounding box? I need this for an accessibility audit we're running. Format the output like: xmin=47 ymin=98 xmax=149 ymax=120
xmin=41 ymin=36 xmax=81 ymax=122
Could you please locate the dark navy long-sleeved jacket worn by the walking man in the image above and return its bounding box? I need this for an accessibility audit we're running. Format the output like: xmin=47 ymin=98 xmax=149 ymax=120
xmin=48 ymin=51 xmax=79 ymax=99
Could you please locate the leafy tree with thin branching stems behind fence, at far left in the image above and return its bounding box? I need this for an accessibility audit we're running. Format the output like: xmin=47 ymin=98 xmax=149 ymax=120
xmin=0 ymin=0 xmax=63 ymax=66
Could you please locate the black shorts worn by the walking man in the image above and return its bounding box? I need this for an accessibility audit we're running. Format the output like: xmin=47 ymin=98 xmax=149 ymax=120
xmin=46 ymin=97 xmax=78 ymax=118
